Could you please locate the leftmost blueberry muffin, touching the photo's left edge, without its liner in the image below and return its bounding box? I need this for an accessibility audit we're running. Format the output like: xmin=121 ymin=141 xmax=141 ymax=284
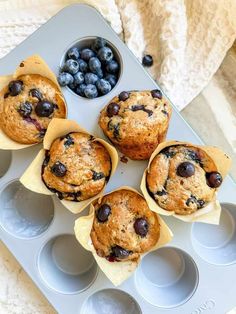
xmin=0 ymin=74 xmax=66 ymax=144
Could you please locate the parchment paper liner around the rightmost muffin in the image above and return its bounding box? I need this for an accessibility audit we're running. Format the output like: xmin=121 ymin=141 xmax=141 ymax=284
xmin=140 ymin=141 xmax=231 ymax=225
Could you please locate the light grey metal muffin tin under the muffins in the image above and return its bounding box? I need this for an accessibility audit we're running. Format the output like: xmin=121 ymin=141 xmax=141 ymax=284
xmin=0 ymin=4 xmax=236 ymax=314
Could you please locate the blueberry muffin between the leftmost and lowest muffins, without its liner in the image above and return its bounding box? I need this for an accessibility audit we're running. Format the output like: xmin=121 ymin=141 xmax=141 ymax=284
xmin=42 ymin=132 xmax=111 ymax=202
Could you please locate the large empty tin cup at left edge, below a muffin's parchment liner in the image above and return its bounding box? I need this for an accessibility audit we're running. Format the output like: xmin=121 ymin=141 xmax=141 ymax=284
xmin=0 ymin=180 xmax=54 ymax=239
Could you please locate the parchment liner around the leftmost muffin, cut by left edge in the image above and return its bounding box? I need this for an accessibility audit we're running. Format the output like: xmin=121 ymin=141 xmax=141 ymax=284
xmin=0 ymin=55 xmax=67 ymax=150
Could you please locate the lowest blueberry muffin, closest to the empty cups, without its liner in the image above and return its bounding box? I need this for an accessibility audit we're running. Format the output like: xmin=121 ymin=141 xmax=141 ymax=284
xmin=91 ymin=189 xmax=160 ymax=262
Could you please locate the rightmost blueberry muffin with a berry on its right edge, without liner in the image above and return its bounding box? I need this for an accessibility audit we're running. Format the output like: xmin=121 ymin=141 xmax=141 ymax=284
xmin=147 ymin=145 xmax=222 ymax=215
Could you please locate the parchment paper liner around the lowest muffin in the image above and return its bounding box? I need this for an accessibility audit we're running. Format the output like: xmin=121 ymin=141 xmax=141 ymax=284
xmin=74 ymin=186 xmax=173 ymax=286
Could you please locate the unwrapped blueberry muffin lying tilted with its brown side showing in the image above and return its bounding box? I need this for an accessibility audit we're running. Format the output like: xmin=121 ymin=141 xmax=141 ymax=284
xmin=99 ymin=90 xmax=172 ymax=160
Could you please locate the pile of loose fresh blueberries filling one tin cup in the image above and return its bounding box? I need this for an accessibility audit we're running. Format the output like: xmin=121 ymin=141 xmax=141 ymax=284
xmin=58 ymin=37 xmax=120 ymax=99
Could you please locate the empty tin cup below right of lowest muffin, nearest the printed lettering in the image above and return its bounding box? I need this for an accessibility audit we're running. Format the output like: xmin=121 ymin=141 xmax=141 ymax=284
xmin=135 ymin=247 xmax=199 ymax=308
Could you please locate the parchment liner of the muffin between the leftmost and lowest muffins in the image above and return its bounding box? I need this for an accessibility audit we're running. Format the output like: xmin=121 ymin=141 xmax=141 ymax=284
xmin=20 ymin=118 xmax=118 ymax=214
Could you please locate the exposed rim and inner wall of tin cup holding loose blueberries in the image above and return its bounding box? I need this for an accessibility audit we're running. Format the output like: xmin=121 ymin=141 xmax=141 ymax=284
xmin=60 ymin=36 xmax=123 ymax=100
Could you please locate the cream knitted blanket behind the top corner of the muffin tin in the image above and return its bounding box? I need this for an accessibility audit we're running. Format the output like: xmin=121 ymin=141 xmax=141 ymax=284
xmin=0 ymin=0 xmax=236 ymax=110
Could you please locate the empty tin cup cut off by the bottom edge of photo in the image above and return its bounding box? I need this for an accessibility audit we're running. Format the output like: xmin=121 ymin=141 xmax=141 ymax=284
xmin=81 ymin=289 xmax=142 ymax=314
